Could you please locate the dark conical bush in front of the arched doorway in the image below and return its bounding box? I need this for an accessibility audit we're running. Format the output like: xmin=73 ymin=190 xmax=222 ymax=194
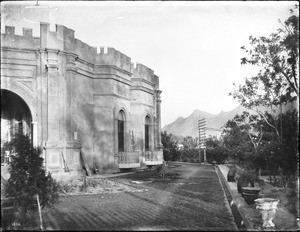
xmin=6 ymin=134 xmax=59 ymax=211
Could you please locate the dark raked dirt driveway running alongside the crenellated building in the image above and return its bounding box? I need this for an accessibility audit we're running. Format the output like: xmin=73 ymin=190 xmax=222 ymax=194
xmin=43 ymin=164 xmax=237 ymax=231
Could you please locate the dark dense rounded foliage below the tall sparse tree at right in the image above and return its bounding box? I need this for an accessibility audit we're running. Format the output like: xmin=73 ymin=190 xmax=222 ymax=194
xmin=222 ymin=110 xmax=299 ymax=181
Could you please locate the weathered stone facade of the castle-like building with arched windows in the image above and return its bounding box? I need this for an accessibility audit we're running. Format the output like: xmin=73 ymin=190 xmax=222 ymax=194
xmin=1 ymin=23 xmax=163 ymax=172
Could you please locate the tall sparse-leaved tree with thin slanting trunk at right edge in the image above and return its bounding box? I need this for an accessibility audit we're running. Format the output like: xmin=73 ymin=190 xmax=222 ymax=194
xmin=230 ymin=6 xmax=299 ymax=142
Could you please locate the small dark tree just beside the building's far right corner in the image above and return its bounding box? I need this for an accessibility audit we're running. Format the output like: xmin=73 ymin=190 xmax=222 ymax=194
xmin=161 ymin=131 xmax=179 ymax=161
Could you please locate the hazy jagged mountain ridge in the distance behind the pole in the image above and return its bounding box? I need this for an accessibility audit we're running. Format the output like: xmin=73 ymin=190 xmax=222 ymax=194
xmin=162 ymin=106 xmax=248 ymax=140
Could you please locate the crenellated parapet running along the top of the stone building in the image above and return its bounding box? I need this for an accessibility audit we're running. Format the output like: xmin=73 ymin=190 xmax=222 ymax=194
xmin=1 ymin=22 xmax=155 ymax=78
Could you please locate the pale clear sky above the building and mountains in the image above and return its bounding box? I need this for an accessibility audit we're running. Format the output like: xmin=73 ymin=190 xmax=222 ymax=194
xmin=1 ymin=1 xmax=297 ymax=127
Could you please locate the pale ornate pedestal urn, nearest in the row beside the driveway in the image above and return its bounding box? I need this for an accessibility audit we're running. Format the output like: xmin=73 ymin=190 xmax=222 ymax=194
xmin=254 ymin=198 xmax=279 ymax=229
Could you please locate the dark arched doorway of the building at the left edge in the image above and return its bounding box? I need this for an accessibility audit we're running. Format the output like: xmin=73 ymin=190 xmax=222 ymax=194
xmin=1 ymin=89 xmax=32 ymax=163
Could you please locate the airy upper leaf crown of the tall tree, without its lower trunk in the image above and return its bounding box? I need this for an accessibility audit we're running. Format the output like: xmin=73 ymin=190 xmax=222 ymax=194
xmin=239 ymin=6 xmax=299 ymax=99
